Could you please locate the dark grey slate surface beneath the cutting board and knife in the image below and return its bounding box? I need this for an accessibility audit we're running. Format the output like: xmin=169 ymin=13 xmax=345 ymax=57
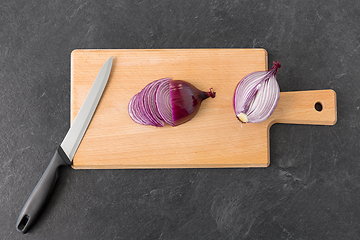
xmin=0 ymin=0 xmax=360 ymax=240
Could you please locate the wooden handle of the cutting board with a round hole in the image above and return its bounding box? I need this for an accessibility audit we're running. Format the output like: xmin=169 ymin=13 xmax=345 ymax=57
xmin=269 ymin=89 xmax=337 ymax=126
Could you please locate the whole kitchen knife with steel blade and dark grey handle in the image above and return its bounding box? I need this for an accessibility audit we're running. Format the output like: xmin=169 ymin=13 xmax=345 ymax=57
xmin=16 ymin=57 xmax=113 ymax=233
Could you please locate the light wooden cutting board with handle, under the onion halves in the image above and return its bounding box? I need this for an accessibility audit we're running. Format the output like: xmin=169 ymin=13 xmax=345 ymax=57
xmin=71 ymin=49 xmax=337 ymax=169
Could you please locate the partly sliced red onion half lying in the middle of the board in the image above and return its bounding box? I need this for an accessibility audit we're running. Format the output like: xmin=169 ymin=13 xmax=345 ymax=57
xmin=128 ymin=78 xmax=215 ymax=127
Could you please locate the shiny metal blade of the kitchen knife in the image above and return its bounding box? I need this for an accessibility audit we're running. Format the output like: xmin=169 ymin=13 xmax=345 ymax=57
xmin=60 ymin=57 xmax=113 ymax=162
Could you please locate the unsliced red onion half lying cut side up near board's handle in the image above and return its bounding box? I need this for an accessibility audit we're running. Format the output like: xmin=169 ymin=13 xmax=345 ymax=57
xmin=234 ymin=62 xmax=281 ymax=123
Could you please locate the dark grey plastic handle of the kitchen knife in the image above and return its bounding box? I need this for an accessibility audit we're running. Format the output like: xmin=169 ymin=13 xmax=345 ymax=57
xmin=16 ymin=146 xmax=71 ymax=233
